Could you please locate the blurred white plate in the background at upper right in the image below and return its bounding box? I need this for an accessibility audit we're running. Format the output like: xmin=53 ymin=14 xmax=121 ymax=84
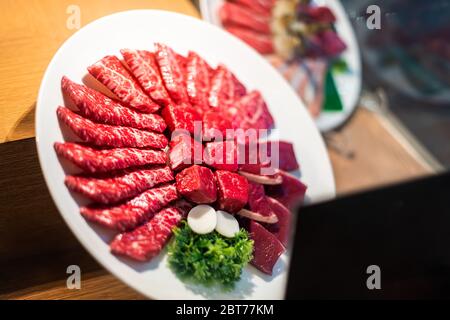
xmin=200 ymin=0 xmax=362 ymax=132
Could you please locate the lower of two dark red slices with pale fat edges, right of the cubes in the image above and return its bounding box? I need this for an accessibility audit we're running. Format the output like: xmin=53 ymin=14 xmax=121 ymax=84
xmin=238 ymin=181 xmax=278 ymax=224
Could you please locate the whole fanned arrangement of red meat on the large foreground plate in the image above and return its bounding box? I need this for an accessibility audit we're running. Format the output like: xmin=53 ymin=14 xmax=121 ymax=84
xmin=54 ymin=43 xmax=306 ymax=282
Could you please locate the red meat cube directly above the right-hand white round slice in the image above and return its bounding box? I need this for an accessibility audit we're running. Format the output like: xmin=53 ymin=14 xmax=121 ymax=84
xmin=215 ymin=170 xmax=248 ymax=213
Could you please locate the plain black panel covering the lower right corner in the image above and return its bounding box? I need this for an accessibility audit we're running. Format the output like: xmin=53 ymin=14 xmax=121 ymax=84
xmin=286 ymin=173 xmax=450 ymax=299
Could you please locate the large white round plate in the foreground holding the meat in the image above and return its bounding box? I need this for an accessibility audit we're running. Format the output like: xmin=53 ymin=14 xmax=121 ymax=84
xmin=36 ymin=10 xmax=335 ymax=299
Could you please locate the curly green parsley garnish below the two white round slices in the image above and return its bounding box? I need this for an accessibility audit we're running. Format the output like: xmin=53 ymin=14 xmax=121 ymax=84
xmin=169 ymin=221 xmax=253 ymax=289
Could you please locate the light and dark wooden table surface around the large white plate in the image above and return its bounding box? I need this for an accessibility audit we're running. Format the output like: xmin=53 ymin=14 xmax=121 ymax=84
xmin=0 ymin=0 xmax=431 ymax=299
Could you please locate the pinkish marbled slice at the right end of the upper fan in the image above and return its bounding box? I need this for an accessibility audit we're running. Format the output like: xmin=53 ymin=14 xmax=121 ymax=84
xmin=232 ymin=90 xmax=275 ymax=130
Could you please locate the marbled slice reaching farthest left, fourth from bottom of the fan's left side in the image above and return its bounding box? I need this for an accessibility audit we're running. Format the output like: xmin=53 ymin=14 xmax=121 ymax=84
xmin=55 ymin=142 xmax=167 ymax=173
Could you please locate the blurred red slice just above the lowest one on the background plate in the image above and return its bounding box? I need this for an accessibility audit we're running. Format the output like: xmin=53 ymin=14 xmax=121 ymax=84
xmin=219 ymin=2 xmax=271 ymax=35
